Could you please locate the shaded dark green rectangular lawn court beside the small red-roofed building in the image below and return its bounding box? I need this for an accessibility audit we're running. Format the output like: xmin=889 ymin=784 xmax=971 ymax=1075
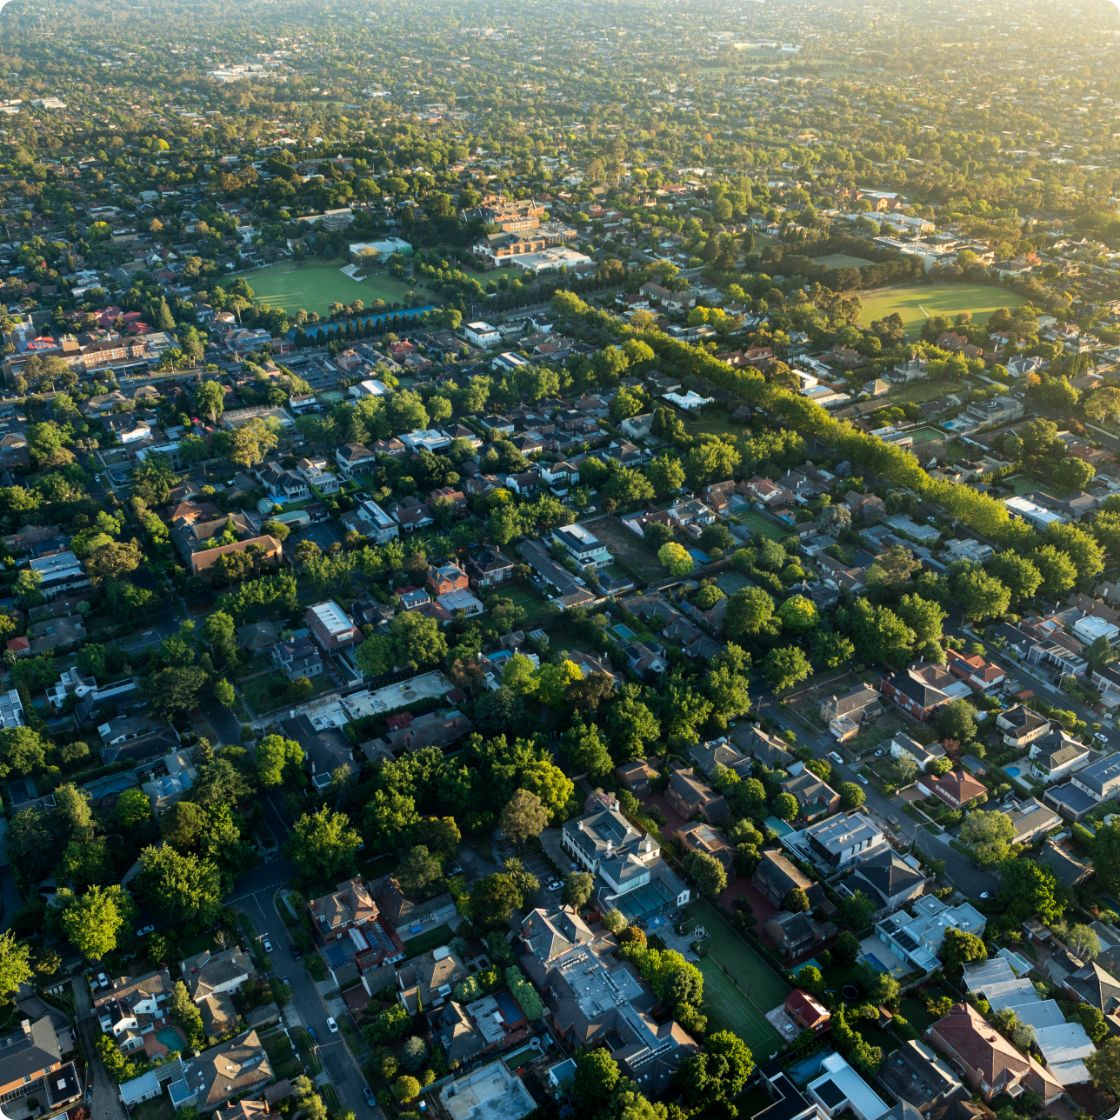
xmin=690 ymin=899 xmax=790 ymax=1061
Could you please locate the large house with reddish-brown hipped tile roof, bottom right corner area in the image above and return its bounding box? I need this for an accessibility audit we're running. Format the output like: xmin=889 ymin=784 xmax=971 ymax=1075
xmin=928 ymin=1004 xmax=1063 ymax=1103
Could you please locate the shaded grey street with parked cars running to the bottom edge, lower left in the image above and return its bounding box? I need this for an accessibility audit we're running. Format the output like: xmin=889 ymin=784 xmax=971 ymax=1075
xmin=230 ymin=856 xmax=370 ymax=1117
